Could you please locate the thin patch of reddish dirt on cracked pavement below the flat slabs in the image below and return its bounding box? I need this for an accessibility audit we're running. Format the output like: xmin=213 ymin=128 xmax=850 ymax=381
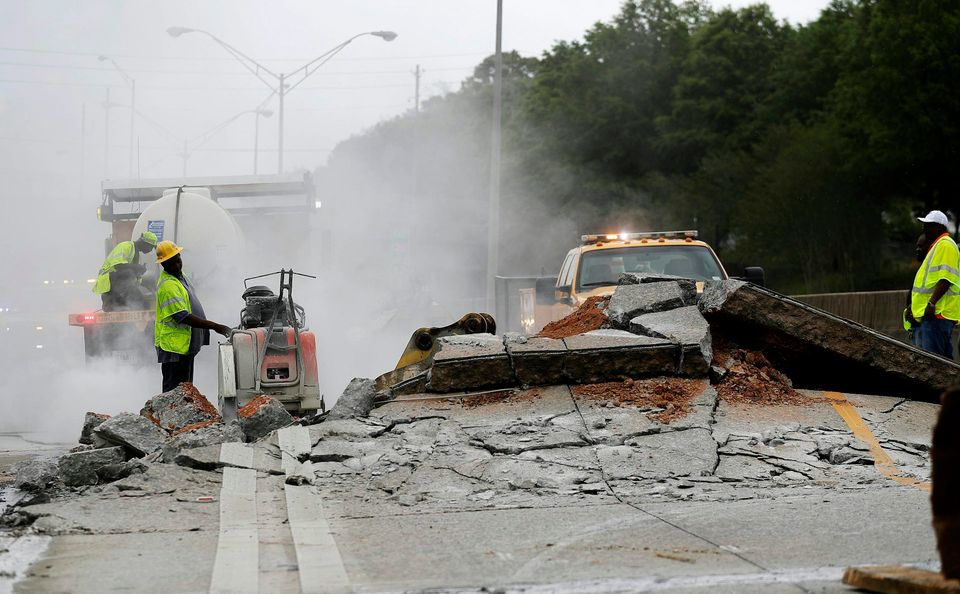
xmin=572 ymin=377 xmax=703 ymax=424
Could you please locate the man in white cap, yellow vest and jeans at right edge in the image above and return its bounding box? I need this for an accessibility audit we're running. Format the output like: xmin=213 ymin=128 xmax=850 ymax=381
xmin=904 ymin=210 xmax=960 ymax=359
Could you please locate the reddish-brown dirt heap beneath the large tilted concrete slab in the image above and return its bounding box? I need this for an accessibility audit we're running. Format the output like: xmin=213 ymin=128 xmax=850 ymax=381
xmin=714 ymin=346 xmax=813 ymax=406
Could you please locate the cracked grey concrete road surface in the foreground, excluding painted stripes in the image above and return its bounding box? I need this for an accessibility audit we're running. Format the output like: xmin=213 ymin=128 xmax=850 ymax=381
xmin=1 ymin=381 xmax=939 ymax=592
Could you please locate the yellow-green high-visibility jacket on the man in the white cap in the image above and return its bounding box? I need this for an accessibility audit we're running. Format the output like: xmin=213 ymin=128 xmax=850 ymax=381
xmin=910 ymin=233 xmax=960 ymax=322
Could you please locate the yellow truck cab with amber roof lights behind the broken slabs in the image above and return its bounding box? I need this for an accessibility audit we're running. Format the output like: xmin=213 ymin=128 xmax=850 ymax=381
xmin=521 ymin=231 xmax=763 ymax=334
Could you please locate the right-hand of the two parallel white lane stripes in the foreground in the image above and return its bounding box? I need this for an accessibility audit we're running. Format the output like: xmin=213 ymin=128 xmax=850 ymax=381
xmin=277 ymin=426 xmax=353 ymax=594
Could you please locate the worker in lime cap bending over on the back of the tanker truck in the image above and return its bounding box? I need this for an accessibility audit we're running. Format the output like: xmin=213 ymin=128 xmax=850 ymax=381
xmin=93 ymin=231 xmax=157 ymax=311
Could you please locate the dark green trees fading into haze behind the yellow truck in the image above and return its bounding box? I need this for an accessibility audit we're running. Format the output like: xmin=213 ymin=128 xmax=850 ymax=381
xmin=319 ymin=0 xmax=960 ymax=293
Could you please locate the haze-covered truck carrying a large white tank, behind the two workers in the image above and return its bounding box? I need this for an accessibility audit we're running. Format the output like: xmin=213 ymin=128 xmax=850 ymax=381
xmin=68 ymin=173 xmax=319 ymax=365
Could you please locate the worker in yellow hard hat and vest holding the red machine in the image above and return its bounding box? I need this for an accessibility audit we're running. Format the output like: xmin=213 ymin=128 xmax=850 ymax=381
xmin=154 ymin=241 xmax=231 ymax=392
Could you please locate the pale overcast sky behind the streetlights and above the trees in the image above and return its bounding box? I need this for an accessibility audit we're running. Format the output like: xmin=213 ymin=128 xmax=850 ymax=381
xmin=0 ymin=0 xmax=826 ymax=182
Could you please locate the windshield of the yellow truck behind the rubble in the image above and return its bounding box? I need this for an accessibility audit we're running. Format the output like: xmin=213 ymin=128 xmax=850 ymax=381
xmin=577 ymin=245 xmax=725 ymax=292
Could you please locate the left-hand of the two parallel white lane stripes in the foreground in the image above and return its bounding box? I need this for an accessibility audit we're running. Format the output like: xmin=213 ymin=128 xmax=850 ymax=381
xmin=210 ymin=443 xmax=260 ymax=593
